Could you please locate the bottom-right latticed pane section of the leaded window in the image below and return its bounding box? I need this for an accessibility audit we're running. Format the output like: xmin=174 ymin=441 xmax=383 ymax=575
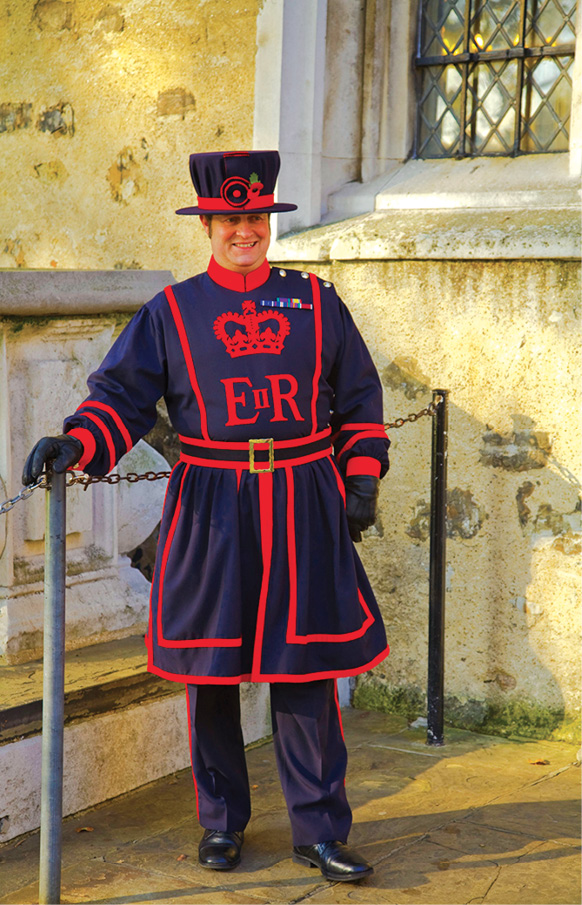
xmin=521 ymin=56 xmax=574 ymax=153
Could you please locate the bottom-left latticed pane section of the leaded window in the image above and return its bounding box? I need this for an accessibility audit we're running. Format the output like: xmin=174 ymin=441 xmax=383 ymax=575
xmin=418 ymin=66 xmax=463 ymax=157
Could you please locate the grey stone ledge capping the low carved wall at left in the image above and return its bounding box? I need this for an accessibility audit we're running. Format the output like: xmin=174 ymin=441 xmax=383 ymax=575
xmin=0 ymin=270 xmax=176 ymax=317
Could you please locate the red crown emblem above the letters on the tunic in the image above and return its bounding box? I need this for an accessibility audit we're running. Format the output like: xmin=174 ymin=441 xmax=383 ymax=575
xmin=214 ymin=299 xmax=291 ymax=358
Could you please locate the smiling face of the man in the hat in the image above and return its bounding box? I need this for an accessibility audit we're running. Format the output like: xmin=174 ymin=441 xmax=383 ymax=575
xmin=200 ymin=213 xmax=271 ymax=274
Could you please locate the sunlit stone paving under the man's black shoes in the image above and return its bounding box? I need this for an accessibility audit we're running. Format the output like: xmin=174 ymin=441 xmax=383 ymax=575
xmin=0 ymin=711 xmax=580 ymax=905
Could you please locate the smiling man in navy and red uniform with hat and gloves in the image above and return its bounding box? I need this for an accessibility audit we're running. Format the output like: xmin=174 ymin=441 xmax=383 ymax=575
xmin=23 ymin=151 xmax=388 ymax=881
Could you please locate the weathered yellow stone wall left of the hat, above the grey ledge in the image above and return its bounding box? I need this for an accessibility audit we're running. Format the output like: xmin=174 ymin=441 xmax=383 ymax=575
xmin=0 ymin=0 xmax=262 ymax=279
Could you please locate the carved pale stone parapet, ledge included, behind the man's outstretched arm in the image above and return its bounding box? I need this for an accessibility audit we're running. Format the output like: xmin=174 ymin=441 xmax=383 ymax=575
xmin=0 ymin=270 xmax=173 ymax=664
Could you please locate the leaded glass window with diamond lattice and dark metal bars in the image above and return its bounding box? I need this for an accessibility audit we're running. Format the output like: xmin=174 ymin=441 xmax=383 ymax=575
xmin=415 ymin=0 xmax=576 ymax=157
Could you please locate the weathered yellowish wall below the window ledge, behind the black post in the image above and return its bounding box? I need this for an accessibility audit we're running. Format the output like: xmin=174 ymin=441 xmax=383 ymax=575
xmin=274 ymin=254 xmax=581 ymax=736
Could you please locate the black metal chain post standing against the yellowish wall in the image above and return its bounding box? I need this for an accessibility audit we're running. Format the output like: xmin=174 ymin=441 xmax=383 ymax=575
xmin=426 ymin=390 xmax=448 ymax=745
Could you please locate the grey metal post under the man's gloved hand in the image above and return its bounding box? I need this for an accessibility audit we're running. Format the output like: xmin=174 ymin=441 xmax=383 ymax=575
xmin=39 ymin=472 xmax=66 ymax=905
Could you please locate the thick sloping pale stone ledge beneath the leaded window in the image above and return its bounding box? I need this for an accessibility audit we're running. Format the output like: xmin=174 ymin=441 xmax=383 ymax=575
xmin=270 ymin=154 xmax=580 ymax=262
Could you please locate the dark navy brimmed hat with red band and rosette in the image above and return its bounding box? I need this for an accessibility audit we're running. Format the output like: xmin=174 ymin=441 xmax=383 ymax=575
xmin=176 ymin=151 xmax=297 ymax=214
